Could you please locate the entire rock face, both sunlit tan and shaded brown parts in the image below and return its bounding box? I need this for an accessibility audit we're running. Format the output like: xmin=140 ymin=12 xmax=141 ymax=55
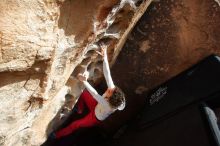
xmin=0 ymin=0 xmax=220 ymax=146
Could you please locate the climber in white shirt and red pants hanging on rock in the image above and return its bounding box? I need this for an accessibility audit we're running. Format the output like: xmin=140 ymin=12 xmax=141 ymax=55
xmin=50 ymin=46 xmax=125 ymax=139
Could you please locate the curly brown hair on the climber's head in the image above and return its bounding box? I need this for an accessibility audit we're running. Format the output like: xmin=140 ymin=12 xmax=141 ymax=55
xmin=108 ymin=86 xmax=125 ymax=108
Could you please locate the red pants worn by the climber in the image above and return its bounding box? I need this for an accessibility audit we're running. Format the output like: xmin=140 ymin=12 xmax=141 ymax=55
xmin=56 ymin=90 xmax=100 ymax=138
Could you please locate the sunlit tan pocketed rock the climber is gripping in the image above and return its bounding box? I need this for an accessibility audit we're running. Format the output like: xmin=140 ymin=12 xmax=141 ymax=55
xmin=0 ymin=0 xmax=151 ymax=146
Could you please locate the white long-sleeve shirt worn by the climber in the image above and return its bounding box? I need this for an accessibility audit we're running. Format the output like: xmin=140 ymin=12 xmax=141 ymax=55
xmin=83 ymin=52 xmax=116 ymax=121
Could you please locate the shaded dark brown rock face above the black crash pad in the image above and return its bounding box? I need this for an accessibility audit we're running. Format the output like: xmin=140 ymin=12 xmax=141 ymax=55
xmin=111 ymin=0 xmax=220 ymax=109
